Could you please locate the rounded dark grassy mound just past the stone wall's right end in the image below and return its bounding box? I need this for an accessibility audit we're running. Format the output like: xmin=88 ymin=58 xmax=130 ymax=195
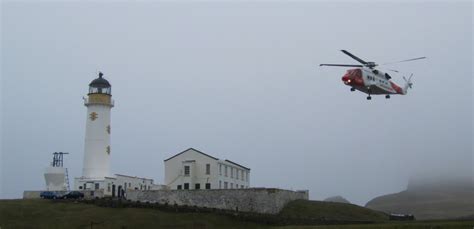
xmin=280 ymin=200 xmax=388 ymax=222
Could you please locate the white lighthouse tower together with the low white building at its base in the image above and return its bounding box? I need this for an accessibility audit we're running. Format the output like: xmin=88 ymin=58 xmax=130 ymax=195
xmin=74 ymin=73 xmax=162 ymax=197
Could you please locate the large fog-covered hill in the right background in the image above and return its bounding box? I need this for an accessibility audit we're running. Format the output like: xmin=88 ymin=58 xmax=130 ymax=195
xmin=366 ymin=182 xmax=474 ymax=220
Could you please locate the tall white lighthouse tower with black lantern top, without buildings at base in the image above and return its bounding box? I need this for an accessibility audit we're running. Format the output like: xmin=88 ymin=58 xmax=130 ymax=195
xmin=82 ymin=72 xmax=114 ymax=179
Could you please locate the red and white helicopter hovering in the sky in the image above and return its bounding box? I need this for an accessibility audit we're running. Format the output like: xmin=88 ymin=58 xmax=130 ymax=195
xmin=319 ymin=50 xmax=426 ymax=100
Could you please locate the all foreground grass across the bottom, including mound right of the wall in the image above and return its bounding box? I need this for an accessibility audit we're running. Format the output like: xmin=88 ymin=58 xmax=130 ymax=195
xmin=0 ymin=200 xmax=474 ymax=229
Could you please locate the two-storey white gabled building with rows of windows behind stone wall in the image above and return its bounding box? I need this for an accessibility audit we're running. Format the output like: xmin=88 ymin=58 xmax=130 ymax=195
xmin=164 ymin=148 xmax=250 ymax=189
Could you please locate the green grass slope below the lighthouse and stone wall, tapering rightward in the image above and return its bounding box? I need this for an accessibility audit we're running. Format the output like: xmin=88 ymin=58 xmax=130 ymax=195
xmin=0 ymin=200 xmax=267 ymax=229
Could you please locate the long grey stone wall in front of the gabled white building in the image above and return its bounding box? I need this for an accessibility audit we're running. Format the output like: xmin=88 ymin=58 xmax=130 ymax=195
xmin=126 ymin=188 xmax=308 ymax=214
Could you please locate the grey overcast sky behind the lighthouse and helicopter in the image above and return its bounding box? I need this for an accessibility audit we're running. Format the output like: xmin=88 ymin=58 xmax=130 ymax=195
xmin=0 ymin=1 xmax=474 ymax=205
